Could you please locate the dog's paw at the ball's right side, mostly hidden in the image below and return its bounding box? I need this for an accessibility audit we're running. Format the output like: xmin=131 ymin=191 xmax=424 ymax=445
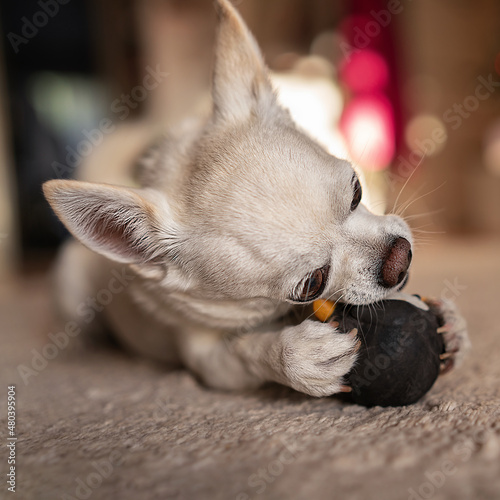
xmin=425 ymin=299 xmax=471 ymax=374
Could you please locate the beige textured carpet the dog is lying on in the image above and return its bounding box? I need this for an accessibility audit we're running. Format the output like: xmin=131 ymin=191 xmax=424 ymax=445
xmin=0 ymin=239 xmax=500 ymax=500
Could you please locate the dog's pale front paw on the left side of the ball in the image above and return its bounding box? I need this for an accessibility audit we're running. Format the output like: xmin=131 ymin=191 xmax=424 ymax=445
xmin=278 ymin=320 xmax=361 ymax=397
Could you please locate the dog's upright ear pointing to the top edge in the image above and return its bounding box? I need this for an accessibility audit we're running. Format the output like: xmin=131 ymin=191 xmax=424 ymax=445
xmin=212 ymin=0 xmax=275 ymax=122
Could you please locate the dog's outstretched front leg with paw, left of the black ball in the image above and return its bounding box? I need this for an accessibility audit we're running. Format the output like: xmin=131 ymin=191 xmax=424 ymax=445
xmin=179 ymin=320 xmax=360 ymax=396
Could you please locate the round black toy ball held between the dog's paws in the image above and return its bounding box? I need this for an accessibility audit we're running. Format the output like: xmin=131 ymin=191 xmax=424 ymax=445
xmin=314 ymin=296 xmax=445 ymax=406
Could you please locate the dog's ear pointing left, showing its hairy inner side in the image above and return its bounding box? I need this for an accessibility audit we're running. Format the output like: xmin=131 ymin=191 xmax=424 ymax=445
xmin=43 ymin=180 xmax=179 ymax=265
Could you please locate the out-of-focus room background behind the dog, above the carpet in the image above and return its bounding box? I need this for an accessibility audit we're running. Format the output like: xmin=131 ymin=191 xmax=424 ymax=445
xmin=0 ymin=0 xmax=500 ymax=277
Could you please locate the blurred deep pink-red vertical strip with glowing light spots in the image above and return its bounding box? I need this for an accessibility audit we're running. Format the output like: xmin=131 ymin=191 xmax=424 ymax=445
xmin=340 ymin=0 xmax=402 ymax=171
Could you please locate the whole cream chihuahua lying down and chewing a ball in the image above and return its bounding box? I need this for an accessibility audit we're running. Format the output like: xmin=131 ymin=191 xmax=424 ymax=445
xmin=45 ymin=0 xmax=464 ymax=396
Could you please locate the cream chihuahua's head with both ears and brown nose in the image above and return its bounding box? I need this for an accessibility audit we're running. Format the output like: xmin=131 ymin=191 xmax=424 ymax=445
xmin=44 ymin=0 xmax=412 ymax=304
